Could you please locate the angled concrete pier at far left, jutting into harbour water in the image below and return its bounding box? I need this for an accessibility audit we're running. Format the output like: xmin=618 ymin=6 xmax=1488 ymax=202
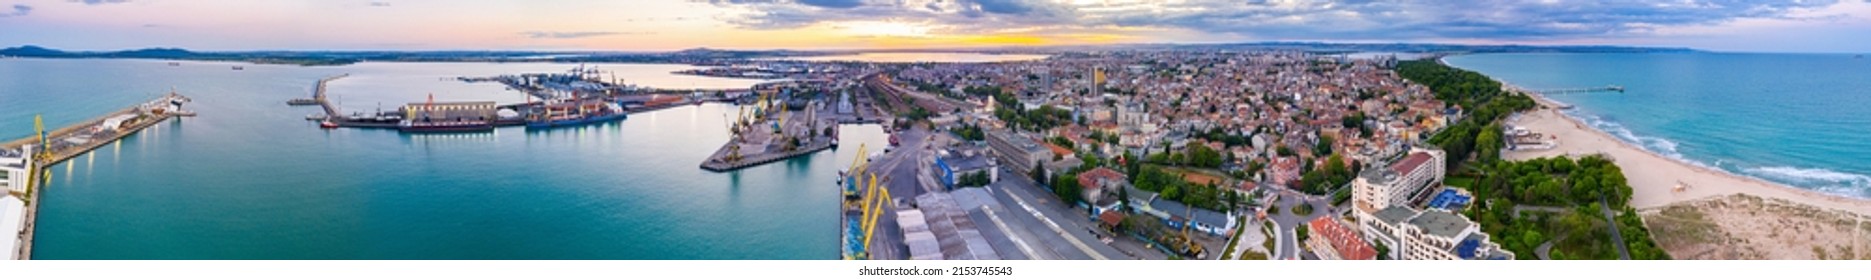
xmin=0 ymin=91 xmax=195 ymax=259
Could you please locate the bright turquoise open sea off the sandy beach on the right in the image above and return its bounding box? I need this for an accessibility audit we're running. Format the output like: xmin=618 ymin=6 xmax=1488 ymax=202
xmin=1444 ymin=52 xmax=1871 ymax=198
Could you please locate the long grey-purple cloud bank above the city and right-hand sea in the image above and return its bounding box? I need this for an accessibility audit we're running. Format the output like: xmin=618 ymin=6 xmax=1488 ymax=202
xmin=692 ymin=0 xmax=1839 ymax=39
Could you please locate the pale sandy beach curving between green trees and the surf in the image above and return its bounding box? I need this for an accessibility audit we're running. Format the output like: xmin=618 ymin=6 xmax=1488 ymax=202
xmin=1495 ymin=86 xmax=1871 ymax=215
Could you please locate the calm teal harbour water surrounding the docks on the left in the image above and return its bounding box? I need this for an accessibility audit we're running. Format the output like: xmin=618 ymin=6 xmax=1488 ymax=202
xmin=0 ymin=58 xmax=885 ymax=259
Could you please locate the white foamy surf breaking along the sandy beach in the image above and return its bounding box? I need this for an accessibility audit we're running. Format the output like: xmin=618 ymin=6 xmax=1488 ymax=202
xmin=1564 ymin=110 xmax=1871 ymax=198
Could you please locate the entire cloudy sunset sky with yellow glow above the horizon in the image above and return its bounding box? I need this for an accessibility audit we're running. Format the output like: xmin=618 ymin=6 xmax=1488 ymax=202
xmin=0 ymin=0 xmax=1871 ymax=52
